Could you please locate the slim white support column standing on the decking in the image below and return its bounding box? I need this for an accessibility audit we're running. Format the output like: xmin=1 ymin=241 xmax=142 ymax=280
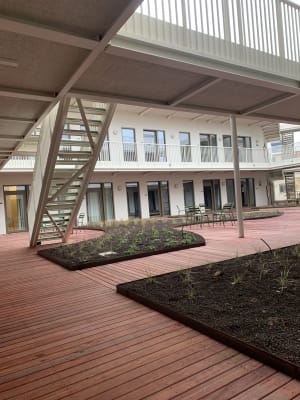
xmin=230 ymin=115 xmax=244 ymax=238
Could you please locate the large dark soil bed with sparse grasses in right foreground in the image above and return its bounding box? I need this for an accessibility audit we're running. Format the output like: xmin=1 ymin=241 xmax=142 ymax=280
xmin=118 ymin=245 xmax=300 ymax=379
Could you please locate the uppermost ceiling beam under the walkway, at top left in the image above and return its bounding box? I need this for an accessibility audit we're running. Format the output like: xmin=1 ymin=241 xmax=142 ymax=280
xmin=0 ymin=15 xmax=99 ymax=50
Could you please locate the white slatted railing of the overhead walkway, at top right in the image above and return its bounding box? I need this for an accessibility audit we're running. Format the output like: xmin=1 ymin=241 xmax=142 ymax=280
xmin=119 ymin=0 xmax=300 ymax=79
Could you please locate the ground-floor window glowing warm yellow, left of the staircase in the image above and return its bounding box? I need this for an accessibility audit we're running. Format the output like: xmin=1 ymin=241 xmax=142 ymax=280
xmin=3 ymin=185 xmax=29 ymax=233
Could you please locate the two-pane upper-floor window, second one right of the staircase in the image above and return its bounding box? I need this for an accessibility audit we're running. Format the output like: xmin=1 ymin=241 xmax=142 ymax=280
xmin=144 ymin=130 xmax=167 ymax=162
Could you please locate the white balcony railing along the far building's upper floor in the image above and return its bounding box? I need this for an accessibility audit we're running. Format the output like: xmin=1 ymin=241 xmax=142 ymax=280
xmin=4 ymin=142 xmax=300 ymax=170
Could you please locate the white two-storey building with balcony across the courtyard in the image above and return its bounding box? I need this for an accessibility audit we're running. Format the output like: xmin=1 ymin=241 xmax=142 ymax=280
xmin=0 ymin=105 xmax=300 ymax=238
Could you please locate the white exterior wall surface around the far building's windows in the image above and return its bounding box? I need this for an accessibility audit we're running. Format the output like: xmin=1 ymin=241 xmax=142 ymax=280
xmin=0 ymin=108 xmax=280 ymax=234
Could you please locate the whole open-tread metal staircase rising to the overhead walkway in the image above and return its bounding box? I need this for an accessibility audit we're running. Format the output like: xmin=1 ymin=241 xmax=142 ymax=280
xmin=28 ymin=98 xmax=115 ymax=246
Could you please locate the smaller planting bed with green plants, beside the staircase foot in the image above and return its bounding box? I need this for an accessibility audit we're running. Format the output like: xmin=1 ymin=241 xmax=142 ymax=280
xmin=38 ymin=220 xmax=205 ymax=270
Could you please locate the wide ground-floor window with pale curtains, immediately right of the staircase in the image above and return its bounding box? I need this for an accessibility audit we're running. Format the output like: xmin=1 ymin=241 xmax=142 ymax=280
xmin=86 ymin=182 xmax=115 ymax=223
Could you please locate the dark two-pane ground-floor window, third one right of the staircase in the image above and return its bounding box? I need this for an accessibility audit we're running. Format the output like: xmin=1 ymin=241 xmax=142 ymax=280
xmin=147 ymin=181 xmax=170 ymax=217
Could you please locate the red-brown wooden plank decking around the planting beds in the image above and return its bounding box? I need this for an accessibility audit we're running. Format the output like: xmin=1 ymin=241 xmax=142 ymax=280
xmin=0 ymin=208 xmax=300 ymax=400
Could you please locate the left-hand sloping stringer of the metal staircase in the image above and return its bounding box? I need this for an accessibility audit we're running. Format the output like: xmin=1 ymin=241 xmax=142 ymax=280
xmin=30 ymin=98 xmax=70 ymax=247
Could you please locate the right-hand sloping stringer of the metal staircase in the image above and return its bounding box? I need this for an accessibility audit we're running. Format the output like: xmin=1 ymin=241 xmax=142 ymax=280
xmin=63 ymin=104 xmax=116 ymax=242
